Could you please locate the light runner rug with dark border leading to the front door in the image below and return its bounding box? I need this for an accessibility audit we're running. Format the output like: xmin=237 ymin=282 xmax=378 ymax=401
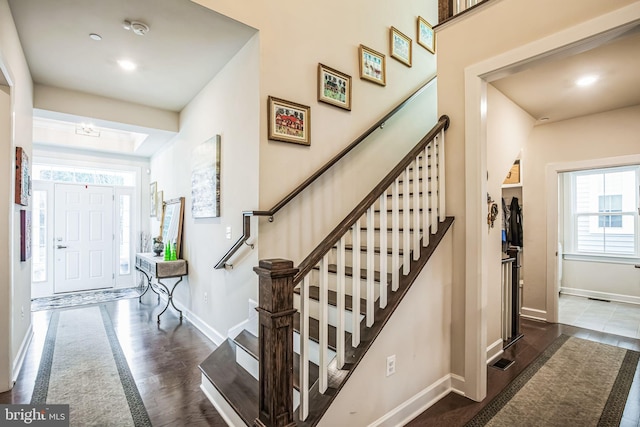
xmin=31 ymin=305 xmax=151 ymax=427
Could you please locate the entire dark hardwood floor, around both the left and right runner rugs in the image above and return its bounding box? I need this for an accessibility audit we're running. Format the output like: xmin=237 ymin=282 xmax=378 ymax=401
xmin=0 ymin=294 xmax=640 ymax=427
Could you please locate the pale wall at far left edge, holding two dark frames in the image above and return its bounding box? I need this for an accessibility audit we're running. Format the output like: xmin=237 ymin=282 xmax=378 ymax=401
xmin=0 ymin=0 xmax=33 ymax=391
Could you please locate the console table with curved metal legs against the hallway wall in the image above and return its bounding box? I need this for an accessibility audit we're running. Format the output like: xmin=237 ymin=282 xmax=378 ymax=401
xmin=136 ymin=252 xmax=187 ymax=323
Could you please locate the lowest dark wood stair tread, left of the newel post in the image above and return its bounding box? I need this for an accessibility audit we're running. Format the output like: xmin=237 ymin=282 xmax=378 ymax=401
xmin=199 ymin=340 xmax=259 ymax=425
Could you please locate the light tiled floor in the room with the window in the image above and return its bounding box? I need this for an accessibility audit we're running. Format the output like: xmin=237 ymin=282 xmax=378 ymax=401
xmin=558 ymin=295 xmax=640 ymax=338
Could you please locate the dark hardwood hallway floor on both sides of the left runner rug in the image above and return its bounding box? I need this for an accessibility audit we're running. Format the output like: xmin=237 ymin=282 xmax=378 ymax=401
xmin=0 ymin=292 xmax=227 ymax=427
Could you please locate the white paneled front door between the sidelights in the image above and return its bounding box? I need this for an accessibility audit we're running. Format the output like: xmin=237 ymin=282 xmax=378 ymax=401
xmin=54 ymin=184 xmax=114 ymax=293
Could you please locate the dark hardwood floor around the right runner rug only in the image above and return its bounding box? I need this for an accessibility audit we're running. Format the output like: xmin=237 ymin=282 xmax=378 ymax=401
xmin=407 ymin=319 xmax=640 ymax=427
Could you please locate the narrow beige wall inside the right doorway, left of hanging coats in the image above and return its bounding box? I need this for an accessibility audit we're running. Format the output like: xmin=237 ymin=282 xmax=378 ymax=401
xmin=486 ymin=85 xmax=535 ymax=359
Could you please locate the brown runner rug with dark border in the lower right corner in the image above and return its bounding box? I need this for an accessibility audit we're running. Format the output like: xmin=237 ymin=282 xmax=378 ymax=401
xmin=467 ymin=335 xmax=640 ymax=427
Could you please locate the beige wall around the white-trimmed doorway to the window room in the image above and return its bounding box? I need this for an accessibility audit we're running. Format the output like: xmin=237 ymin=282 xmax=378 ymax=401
xmin=523 ymin=106 xmax=640 ymax=317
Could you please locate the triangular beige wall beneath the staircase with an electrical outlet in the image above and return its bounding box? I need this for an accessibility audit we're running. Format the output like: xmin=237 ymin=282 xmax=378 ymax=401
xmin=319 ymin=232 xmax=455 ymax=426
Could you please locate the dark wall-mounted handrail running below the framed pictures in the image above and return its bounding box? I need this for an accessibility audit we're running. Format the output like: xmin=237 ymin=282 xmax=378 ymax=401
xmin=215 ymin=75 xmax=436 ymax=269
